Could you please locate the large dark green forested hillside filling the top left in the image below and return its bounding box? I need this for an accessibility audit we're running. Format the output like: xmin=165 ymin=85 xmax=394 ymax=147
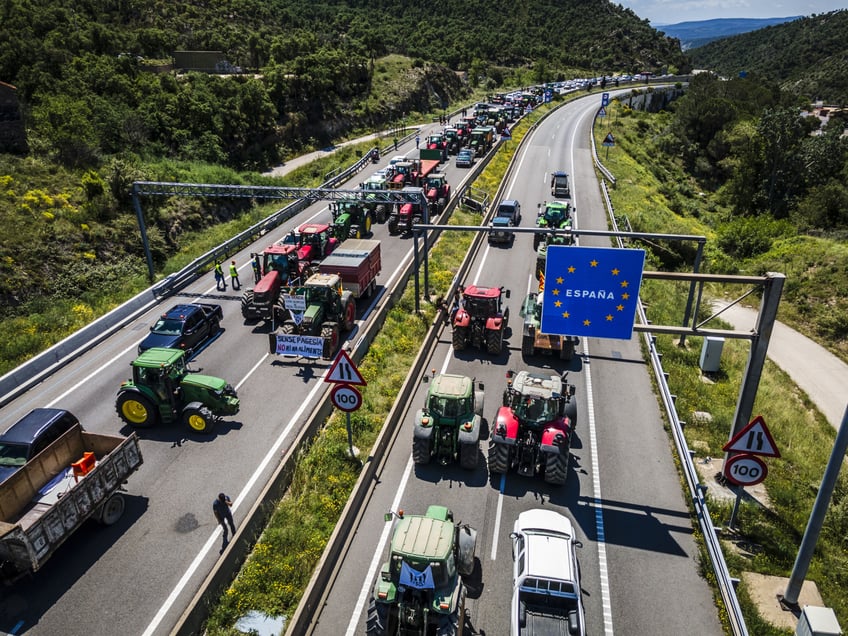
xmin=0 ymin=0 xmax=685 ymax=168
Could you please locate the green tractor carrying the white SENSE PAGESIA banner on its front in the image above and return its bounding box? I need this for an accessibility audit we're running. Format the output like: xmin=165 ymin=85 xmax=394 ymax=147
xmin=269 ymin=273 xmax=356 ymax=360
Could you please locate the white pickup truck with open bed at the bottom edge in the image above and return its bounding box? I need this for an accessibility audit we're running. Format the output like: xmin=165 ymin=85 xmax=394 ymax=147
xmin=510 ymin=509 xmax=586 ymax=636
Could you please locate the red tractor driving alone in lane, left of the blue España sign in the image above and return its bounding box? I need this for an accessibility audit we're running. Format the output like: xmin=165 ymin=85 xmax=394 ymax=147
xmin=451 ymin=285 xmax=509 ymax=355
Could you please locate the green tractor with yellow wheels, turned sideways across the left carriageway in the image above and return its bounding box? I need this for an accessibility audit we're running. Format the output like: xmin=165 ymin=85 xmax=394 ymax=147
xmin=115 ymin=347 xmax=239 ymax=433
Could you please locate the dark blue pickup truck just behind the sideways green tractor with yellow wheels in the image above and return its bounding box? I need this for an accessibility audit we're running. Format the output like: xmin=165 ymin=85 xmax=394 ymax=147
xmin=138 ymin=303 xmax=224 ymax=355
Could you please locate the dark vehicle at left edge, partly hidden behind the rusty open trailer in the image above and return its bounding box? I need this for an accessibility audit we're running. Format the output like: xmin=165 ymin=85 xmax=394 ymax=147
xmin=0 ymin=409 xmax=79 ymax=482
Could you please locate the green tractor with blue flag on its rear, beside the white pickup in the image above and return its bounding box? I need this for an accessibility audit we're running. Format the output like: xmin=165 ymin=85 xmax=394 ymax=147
xmin=365 ymin=506 xmax=477 ymax=636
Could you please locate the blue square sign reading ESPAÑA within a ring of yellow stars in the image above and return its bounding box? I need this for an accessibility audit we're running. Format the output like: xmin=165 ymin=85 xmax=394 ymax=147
xmin=541 ymin=245 xmax=645 ymax=340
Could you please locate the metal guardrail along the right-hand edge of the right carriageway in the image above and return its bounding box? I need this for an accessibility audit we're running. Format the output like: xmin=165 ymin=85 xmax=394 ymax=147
xmin=592 ymin=168 xmax=748 ymax=636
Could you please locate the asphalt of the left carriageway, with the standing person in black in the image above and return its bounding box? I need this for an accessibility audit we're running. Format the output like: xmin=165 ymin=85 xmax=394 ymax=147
xmin=0 ymin=126 xmax=468 ymax=636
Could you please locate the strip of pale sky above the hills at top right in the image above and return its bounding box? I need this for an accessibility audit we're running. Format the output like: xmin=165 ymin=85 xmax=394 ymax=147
xmin=611 ymin=0 xmax=848 ymax=26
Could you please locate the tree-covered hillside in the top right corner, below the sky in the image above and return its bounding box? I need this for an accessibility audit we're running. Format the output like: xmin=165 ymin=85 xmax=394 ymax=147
xmin=687 ymin=9 xmax=848 ymax=106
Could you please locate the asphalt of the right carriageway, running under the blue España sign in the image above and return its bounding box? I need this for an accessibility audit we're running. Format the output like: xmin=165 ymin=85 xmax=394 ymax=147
xmin=314 ymin=96 xmax=722 ymax=636
